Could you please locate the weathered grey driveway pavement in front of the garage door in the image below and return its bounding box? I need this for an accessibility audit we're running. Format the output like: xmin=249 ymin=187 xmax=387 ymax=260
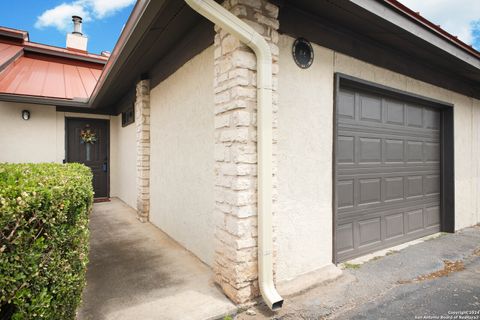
xmin=234 ymin=227 xmax=480 ymax=320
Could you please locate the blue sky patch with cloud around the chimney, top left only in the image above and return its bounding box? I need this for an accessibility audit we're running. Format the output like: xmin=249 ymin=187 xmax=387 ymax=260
xmin=0 ymin=0 xmax=135 ymax=53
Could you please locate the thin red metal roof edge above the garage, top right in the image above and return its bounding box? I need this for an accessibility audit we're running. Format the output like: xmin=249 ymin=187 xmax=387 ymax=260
xmin=384 ymin=0 xmax=480 ymax=58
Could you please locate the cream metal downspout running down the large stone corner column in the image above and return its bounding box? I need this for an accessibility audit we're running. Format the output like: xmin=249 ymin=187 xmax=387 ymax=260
xmin=185 ymin=0 xmax=283 ymax=310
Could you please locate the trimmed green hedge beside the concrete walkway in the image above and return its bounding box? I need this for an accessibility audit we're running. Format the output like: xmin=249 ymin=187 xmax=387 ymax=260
xmin=0 ymin=163 xmax=93 ymax=320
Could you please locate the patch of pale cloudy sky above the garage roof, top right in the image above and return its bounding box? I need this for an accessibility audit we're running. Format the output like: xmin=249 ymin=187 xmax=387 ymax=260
xmin=400 ymin=0 xmax=480 ymax=44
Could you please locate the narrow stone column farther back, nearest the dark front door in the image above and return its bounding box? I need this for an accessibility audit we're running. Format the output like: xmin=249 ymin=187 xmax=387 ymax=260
xmin=135 ymin=80 xmax=150 ymax=222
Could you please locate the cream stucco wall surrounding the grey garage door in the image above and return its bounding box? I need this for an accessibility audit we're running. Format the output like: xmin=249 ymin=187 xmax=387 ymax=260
xmin=276 ymin=35 xmax=480 ymax=281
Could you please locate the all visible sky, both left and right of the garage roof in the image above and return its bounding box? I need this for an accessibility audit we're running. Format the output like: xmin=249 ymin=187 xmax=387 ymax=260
xmin=0 ymin=0 xmax=480 ymax=53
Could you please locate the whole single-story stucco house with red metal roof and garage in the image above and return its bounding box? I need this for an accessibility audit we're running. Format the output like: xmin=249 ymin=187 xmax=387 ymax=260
xmin=0 ymin=0 xmax=480 ymax=308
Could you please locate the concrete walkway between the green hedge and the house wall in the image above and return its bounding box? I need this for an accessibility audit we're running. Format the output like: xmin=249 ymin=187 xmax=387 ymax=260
xmin=77 ymin=199 xmax=235 ymax=320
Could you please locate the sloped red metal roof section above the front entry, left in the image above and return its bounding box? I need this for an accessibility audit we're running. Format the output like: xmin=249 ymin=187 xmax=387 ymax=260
xmin=0 ymin=28 xmax=107 ymax=101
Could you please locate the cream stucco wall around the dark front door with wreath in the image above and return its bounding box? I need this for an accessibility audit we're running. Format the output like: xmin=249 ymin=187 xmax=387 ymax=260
xmin=0 ymin=101 xmax=136 ymax=207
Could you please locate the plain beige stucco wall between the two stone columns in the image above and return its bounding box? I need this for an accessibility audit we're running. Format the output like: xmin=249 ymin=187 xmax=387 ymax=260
xmin=150 ymin=47 xmax=214 ymax=265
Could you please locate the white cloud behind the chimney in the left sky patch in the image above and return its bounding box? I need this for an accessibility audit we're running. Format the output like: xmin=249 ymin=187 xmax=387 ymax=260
xmin=35 ymin=0 xmax=135 ymax=32
